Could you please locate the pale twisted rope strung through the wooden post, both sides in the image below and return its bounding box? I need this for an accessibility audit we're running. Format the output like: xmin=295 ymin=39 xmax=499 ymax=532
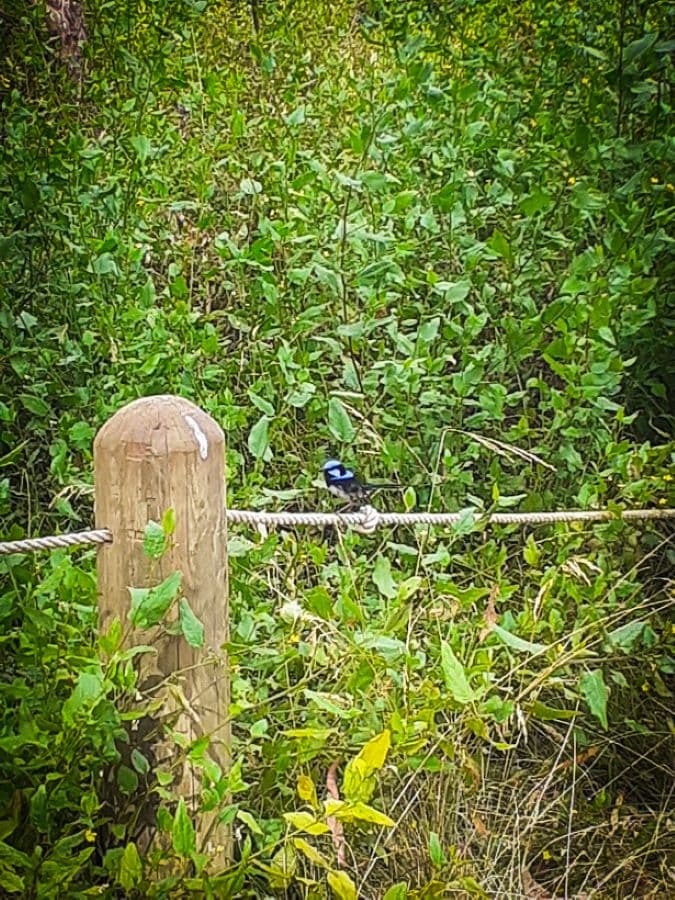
xmin=0 ymin=506 xmax=675 ymax=556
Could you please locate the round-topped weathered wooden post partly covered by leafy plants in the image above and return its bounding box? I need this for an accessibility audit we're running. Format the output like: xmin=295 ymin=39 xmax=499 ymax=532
xmin=94 ymin=395 xmax=230 ymax=870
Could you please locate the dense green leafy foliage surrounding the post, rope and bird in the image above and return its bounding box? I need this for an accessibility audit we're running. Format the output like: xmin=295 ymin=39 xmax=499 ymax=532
xmin=0 ymin=0 xmax=675 ymax=898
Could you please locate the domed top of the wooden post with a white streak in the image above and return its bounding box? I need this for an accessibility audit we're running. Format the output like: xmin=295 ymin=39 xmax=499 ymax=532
xmin=94 ymin=394 xmax=225 ymax=460
